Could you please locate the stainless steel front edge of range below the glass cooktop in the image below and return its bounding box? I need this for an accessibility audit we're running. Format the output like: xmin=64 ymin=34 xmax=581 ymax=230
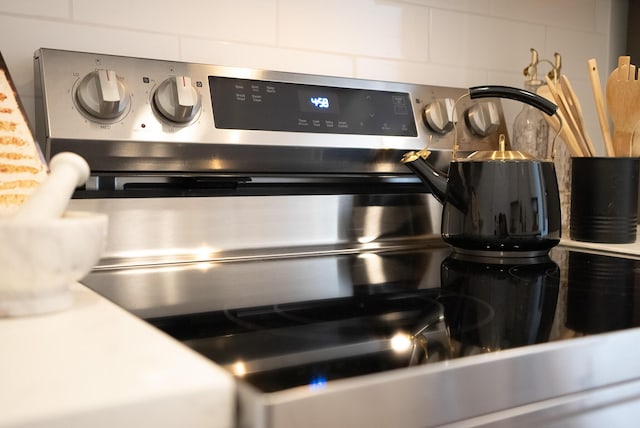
xmin=239 ymin=329 xmax=640 ymax=428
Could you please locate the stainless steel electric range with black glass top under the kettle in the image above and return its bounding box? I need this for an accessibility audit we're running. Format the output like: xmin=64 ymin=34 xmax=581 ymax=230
xmin=35 ymin=49 xmax=640 ymax=427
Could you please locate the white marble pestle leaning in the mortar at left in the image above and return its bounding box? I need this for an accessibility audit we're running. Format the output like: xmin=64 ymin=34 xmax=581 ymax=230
xmin=14 ymin=152 xmax=90 ymax=222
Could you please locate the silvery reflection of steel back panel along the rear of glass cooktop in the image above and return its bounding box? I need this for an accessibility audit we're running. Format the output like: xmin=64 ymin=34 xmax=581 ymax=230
xmin=83 ymin=246 xmax=451 ymax=319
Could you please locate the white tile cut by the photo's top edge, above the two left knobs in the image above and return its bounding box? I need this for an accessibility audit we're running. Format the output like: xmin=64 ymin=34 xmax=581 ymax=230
xmin=73 ymin=0 xmax=276 ymax=45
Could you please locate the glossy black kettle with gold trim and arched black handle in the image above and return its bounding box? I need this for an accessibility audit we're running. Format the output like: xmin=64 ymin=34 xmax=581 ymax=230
xmin=402 ymin=86 xmax=561 ymax=257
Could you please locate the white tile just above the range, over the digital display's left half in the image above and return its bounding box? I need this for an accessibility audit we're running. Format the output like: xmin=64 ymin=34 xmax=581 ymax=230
xmin=180 ymin=38 xmax=354 ymax=77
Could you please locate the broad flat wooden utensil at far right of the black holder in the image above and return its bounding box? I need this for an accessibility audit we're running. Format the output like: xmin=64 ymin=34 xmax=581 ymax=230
xmin=606 ymin=56 xmax=640 ymax=156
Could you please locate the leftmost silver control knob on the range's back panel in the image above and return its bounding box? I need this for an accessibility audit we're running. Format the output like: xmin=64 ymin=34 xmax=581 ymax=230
xmin=76 ymin=69 xmax=129 ymax=119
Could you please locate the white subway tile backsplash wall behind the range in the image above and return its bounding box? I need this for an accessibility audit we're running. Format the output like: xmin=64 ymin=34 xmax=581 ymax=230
xmin=0 ymin=0 xmax=626 ymax=155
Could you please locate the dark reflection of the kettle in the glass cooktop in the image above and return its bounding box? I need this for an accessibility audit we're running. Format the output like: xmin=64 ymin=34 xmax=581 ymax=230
xmin=440 ymin=253 xmax=560 ymax=355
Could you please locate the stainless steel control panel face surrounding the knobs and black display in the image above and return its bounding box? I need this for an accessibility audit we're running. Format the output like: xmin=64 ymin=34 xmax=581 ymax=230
xmin=34 ymin=49 xmax=507 ymax=174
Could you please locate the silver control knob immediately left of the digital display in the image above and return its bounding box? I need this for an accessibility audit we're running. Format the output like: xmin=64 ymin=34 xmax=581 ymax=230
xmin=153 ymin=76 xmax=200 ymax=123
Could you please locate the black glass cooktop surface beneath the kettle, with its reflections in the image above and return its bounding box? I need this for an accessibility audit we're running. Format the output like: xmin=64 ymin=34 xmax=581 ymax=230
xmin=84 ymin=248 xmax=640 ymax=392
